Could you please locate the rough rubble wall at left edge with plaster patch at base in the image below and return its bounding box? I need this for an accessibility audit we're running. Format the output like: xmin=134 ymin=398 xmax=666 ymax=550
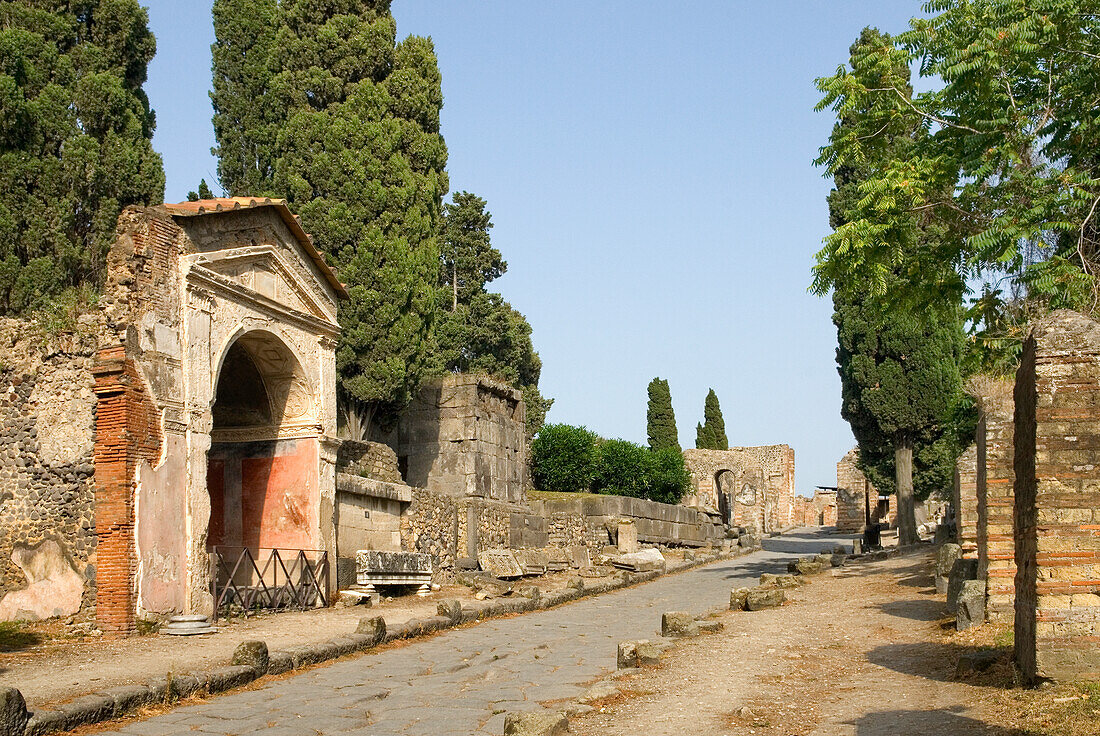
xmin=0 ymin=316 xmax=97 ymax=620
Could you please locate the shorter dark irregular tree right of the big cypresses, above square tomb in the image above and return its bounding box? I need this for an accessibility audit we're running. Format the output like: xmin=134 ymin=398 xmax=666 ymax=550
xmin=432 ymin=191 xmax=553 ymax=438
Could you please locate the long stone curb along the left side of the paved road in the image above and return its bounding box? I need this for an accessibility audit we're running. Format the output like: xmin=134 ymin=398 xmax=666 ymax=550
xmin=8 ymin=539 xmax=760 ymax=736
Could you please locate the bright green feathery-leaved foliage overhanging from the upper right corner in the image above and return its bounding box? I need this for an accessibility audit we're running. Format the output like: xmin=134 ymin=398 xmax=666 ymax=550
xmin=814 ymin=0 xmax=1100 ymax=371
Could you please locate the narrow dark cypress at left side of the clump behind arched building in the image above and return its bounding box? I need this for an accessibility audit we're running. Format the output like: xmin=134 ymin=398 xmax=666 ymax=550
xmin=210 ymin=0 xmax=277 ymax=197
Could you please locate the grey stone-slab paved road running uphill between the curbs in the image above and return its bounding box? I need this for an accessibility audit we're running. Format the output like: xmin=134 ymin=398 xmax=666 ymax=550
xmin=101 ymin=529 xmax=840 ymax=736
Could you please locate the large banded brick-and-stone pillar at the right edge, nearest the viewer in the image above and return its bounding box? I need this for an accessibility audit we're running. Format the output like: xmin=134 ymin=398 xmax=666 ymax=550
xmin=1013 ymin=310 xmax=1100 ymax=685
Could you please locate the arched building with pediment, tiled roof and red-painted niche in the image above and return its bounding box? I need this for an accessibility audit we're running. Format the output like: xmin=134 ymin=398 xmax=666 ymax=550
xmin=95 ymin=198 xmax=345 ymax=633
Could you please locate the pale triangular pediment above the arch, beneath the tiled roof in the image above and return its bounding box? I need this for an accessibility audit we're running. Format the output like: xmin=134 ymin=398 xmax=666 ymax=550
xmin=199 ymin=245 xmax=336 ymax=323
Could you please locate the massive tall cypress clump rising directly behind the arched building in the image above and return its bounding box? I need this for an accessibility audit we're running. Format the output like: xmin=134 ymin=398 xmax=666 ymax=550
xmin=215 ymin=0 xmax=448 ymax=436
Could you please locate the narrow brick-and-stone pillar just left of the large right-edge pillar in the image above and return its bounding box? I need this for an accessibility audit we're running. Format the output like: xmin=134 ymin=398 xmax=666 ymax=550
xmin=970 ymin=378 xmax=1016 ymax=620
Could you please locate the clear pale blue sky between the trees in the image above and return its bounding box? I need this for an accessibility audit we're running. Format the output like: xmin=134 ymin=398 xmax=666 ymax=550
xmin=145 ymin=0 xmax=921 ymax=493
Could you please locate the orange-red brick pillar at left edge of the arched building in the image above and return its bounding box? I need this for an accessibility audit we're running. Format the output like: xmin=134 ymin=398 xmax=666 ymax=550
xmin=92 ymin=345 xmax=161 ymax=637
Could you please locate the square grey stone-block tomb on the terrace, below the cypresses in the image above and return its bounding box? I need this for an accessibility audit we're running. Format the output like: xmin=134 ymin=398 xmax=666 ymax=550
xmin=397 ymin=374 xmax=528 ymax=504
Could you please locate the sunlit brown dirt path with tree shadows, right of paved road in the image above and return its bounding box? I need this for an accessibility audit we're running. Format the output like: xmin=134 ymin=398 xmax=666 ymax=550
xmin=571 ymin=553 xmax=1037 ymax=736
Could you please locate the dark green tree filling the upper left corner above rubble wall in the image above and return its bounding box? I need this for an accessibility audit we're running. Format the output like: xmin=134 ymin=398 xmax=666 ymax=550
xmin=0 ymin=0 xmax=164 ymax=312
